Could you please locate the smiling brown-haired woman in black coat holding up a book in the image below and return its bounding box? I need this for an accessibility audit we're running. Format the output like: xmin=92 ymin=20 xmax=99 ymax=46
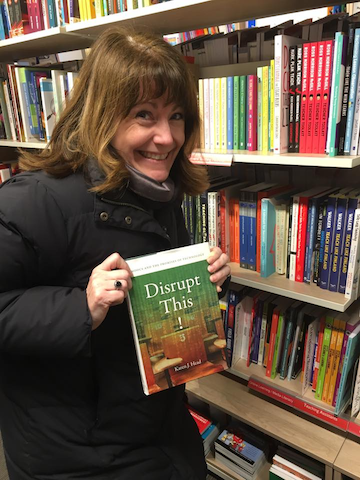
xmin=0 ymin=30 xmax=230 ymax=480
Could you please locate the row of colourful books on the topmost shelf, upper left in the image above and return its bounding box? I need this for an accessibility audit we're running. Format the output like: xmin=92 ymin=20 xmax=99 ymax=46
xmin=0 ymin=0 xmax=170 ymax=40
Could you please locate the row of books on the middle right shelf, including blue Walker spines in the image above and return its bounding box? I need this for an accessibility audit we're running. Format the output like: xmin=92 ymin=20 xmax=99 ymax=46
xmin=183 ymin=180 xmax=360 ymax=298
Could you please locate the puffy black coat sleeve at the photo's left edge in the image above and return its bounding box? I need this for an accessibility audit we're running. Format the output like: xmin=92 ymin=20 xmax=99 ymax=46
xmin=0 ymin=174 xmax=92 ymax=357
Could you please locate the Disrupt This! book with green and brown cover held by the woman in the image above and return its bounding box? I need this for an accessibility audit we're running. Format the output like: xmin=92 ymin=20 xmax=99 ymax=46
xmin=127 ymin=243 xmax=227 ymax=395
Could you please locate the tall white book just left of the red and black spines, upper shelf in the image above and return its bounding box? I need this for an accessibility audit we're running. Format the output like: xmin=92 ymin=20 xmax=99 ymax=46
xmin=274 ymin=35 xmax=303 ymax=154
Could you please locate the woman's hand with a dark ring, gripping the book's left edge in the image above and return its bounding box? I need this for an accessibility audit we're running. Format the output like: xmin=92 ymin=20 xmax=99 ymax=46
xmin=86 ymin=253 xmax=132 ymax=330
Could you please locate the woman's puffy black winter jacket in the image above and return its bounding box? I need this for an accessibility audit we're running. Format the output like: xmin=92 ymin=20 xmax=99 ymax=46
xmin=0 ymin=167 xmax=206 ymax=480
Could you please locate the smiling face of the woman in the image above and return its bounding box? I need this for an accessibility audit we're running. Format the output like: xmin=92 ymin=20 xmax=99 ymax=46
xmin=111 ymin=95 xmax=185 ymax=182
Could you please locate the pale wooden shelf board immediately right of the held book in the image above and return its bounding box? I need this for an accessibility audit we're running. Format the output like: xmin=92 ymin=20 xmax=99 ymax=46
xmin=230 ymin=263 xmax=353 ymax=312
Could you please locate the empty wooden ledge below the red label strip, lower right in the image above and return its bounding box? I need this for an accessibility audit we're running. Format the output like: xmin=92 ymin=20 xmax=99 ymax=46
xmin=187 ymin=374 xmax=346 ymax=467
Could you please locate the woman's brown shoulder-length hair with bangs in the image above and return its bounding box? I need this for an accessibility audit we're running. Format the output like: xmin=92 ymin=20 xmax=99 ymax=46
xmin=20 ymin=28 xmax=208 ymax=195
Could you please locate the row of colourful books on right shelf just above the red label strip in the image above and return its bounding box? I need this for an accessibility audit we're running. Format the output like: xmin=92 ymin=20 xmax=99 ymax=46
xmin=225 ymin=287 xmax=360 ymax=415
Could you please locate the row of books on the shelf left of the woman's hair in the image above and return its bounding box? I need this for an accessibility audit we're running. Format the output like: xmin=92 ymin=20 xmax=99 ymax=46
xmin=0 ymin=65 xmax=78 ymax=142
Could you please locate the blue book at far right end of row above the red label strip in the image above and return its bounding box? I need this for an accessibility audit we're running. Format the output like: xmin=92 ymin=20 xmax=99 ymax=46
xmin=335 ymin=325 xmax=360 ymax=416
